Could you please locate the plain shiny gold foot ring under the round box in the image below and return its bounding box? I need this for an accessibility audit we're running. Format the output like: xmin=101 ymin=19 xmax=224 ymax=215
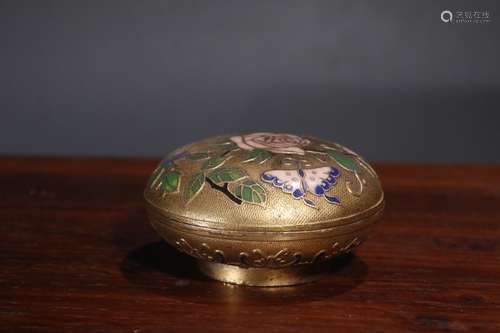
xmin=198 ymin=260 xmax=324 ymax=287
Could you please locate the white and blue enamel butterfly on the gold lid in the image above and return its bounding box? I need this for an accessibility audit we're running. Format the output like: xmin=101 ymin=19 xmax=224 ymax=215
xmin=261 ymin=166 xmax=340 ymax=207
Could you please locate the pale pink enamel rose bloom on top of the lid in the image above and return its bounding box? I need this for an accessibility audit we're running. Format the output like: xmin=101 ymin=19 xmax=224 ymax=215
xmin=231 ymin=132 xmax=310 ymax=155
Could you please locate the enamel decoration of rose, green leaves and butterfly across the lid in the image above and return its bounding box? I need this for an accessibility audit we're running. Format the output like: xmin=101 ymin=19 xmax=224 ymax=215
xmin=149 ymin=132 xmax=370 ymax=208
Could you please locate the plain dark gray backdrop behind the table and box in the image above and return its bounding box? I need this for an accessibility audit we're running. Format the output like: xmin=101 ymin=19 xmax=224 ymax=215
xmin=0 ymin=0 xmax=500 ymax=162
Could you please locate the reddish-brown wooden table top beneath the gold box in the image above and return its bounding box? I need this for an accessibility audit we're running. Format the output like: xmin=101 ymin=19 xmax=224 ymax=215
xmin=0 ymin=157 xmax=500 ymax=333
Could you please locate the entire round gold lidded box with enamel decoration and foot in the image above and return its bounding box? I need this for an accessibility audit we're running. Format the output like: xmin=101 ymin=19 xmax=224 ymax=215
xmin=144 ymin=133 xmax=384 ymax=286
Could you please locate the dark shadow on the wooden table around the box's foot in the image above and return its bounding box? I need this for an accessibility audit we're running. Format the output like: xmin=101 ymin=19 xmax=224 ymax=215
xmin=121 ymin=241 xmax=368 ymax=304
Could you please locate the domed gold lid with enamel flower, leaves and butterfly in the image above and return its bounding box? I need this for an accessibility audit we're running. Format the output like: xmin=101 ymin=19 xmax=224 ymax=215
xmin=144 ymin=133 xmax=384 ymax=231
